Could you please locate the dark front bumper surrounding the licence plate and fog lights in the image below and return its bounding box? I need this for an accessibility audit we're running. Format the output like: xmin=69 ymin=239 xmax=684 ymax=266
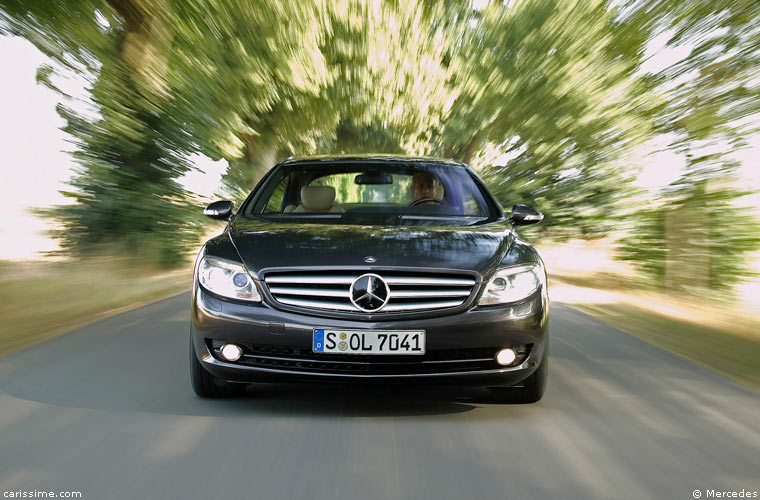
xmin=192 ymin=286 xmax=548 ymax=386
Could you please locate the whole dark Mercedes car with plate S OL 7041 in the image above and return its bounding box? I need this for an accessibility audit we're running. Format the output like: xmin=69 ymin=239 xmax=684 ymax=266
xmin=190 ymin=156 xmax=549 ymax=402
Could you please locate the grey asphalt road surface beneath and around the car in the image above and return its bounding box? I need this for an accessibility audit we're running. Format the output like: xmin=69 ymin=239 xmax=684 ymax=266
xmin=0 ymin=294 xmax=760 ymax=500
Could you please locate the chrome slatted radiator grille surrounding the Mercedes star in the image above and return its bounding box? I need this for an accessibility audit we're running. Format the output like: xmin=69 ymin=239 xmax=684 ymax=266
xmin=263 ymin=270 xmax=476 ymax=314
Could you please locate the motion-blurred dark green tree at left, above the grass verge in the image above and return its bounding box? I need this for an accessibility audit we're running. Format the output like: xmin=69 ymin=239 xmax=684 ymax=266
xmin=2 ymin=0 xmax=205 ymax=264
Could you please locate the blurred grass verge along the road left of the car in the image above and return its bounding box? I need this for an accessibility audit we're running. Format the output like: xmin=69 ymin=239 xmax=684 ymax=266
xmin=0 ymin=258 xmax=192 ymax=354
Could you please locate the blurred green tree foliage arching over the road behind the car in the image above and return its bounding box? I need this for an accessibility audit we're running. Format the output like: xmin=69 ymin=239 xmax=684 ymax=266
xmin=0 ymin=0 xmax=760 ymax=288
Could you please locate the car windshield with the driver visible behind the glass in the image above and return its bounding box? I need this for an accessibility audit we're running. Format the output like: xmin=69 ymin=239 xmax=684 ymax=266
xmin=244 ymin=162 xmax=495 ymax=225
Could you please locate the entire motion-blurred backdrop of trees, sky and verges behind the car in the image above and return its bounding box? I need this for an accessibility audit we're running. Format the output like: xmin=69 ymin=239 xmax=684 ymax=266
xmin=0 ymin=0 xmax=760 ymax=387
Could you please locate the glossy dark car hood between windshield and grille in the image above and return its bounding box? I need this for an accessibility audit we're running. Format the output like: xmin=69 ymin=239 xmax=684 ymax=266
xmin=229 ymin=217 xmax=514 ymax=276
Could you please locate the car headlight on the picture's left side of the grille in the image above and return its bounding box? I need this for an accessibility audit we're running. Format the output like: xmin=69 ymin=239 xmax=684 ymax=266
xmin=198 ymin=256 xmax=261 ymax=302
